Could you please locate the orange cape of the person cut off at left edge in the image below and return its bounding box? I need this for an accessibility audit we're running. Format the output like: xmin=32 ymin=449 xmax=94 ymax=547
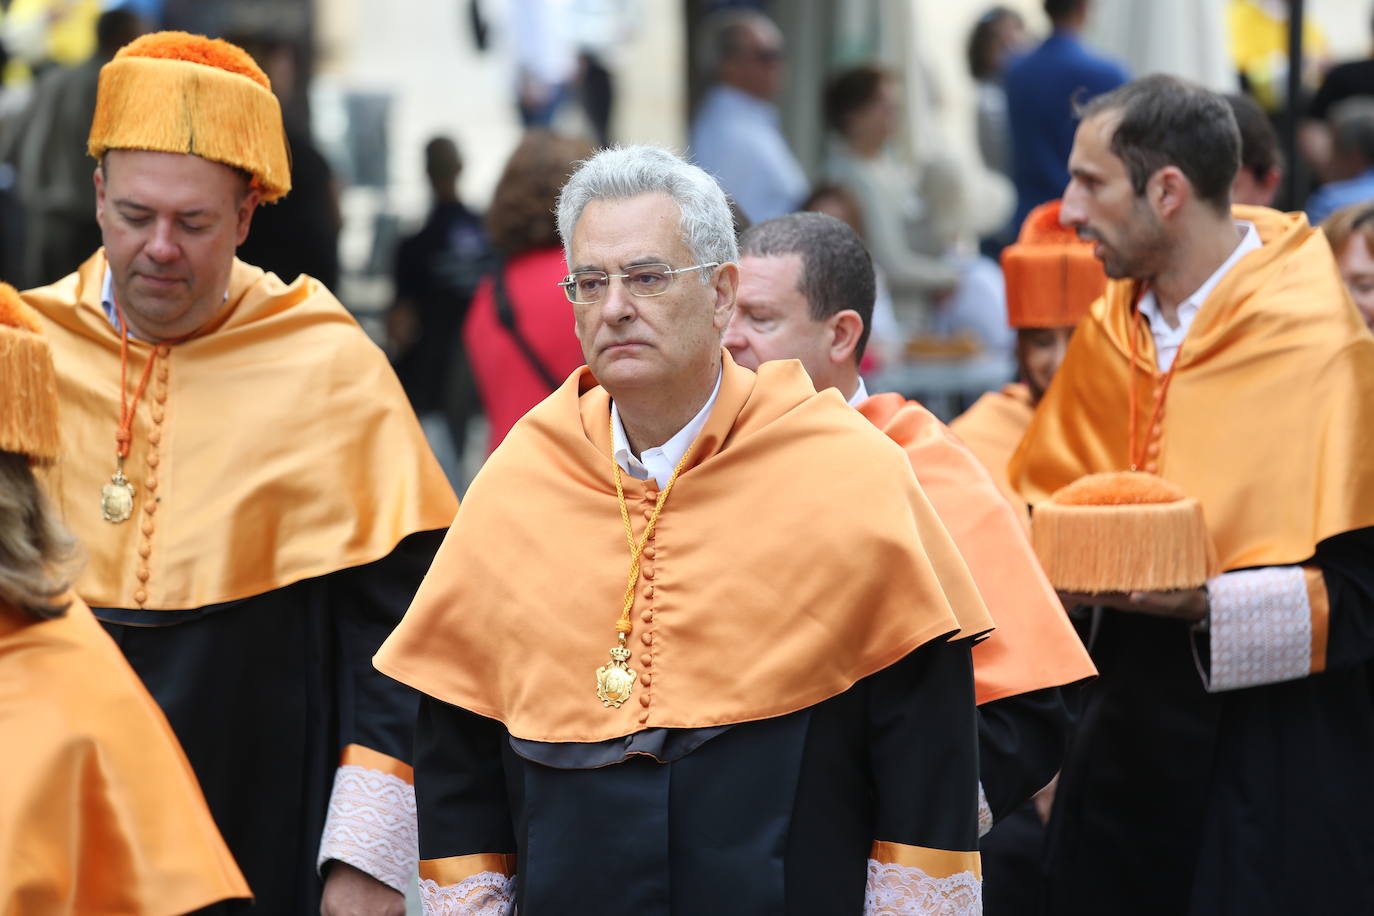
xmin=0 ymin=599 xmax=249 ymax=916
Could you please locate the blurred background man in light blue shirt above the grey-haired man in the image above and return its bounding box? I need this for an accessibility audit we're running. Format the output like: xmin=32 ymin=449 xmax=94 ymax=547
xmin=691 ymin=10 xmax=807 ymax=222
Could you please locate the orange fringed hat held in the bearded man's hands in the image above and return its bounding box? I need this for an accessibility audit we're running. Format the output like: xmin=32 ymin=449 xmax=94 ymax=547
xmin=1031 ymin=471 xmax=1216 ymax=593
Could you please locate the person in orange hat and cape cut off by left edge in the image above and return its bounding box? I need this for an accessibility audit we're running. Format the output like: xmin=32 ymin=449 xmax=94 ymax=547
xmin=0 ymin=283 xmax=249 ymax=916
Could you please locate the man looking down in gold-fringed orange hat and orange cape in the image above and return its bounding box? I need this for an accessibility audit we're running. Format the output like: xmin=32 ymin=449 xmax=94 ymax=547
xmin=25 ymin=33 xmax=456 ymax=913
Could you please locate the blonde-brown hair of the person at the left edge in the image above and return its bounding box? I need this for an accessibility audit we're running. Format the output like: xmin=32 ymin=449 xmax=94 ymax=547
xmin=0 ymin=450 xmax=76 ymax=619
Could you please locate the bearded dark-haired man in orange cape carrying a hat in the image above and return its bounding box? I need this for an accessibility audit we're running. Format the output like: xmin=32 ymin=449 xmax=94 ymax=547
xmin=1010 ymin=76 xmax=1374 ymax=916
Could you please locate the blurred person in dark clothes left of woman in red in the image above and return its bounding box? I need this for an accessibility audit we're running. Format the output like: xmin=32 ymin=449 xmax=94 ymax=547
xmin=386 ymin=137 xmax=489 ymax=459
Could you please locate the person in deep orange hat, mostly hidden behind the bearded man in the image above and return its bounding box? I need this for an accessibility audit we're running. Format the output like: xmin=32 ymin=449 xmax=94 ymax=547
xmin=949 ymin=201 xmax=1107 ymax=515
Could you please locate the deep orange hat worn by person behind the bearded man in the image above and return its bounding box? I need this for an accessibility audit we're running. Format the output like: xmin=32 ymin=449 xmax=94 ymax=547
xmin=1002 ymin=201 xmax=1107 ymax=328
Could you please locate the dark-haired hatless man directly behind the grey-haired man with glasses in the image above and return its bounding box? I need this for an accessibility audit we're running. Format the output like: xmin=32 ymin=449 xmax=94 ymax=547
xmin=725 ymin=213 xmax=1094 ymax=867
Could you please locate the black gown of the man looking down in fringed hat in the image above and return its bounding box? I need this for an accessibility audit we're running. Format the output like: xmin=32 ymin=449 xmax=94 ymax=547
xmin=102 ymin=531 xmax=444 ymax=916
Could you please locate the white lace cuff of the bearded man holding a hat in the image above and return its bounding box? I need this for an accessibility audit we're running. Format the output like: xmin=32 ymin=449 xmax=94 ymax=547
xmin=1208 ymin=566 xmax=1312 ymax=694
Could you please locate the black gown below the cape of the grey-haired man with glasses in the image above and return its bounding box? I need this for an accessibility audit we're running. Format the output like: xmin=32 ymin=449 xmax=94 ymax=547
xmin=415 ymin=641 xmax=978 ymax=916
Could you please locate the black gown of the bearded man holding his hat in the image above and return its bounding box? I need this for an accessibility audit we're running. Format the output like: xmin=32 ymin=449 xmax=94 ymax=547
xmin=1043 ymin=529 xmax=1374 ymax=916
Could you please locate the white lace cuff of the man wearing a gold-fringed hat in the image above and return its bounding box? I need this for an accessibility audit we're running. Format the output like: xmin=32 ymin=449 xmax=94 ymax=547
xmin=317 ymin=764 xmax=417 ymax=889
